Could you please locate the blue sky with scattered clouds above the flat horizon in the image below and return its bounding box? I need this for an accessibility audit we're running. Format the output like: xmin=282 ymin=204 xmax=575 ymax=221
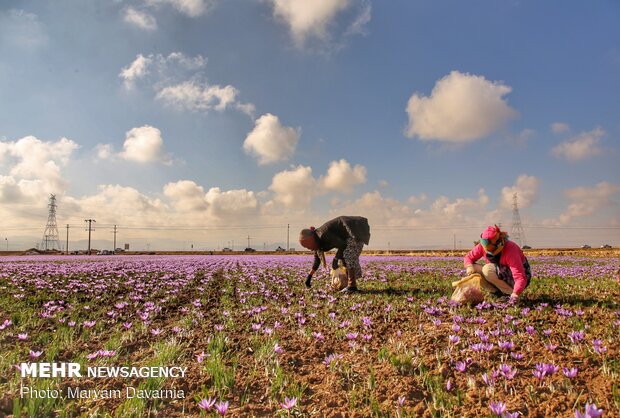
xmin=0 ymin=0 xmax=620 ymax=250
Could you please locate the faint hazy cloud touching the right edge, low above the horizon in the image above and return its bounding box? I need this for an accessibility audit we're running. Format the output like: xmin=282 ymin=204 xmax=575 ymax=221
xmin=556 ymin=181 xmax=620 ymax=225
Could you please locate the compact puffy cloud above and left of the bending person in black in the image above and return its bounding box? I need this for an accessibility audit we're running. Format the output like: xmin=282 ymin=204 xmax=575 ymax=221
xmin=243 ymin=113 xmax=300 ymax=165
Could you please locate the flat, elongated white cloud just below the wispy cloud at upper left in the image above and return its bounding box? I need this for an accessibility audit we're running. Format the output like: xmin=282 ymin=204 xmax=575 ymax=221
xmin=156 ymin=81 xmax=239 ymax=111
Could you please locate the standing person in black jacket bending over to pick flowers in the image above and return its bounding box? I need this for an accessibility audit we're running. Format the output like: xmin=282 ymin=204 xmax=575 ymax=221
xmin=299 ymin=216 xmax=370 ymax=293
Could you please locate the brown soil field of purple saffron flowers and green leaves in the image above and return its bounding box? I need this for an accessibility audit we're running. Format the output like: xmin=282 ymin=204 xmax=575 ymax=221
xmin=0 ymin=255 xmax=620 ymax=417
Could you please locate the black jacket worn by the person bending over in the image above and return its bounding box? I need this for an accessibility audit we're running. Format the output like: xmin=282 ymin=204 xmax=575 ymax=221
xmin=312 ymin=216 xmax=370 ymax=270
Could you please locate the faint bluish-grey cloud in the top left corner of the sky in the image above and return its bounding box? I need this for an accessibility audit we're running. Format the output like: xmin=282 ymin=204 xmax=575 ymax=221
xmin=0 ymin=9 xmax=48 ymax=50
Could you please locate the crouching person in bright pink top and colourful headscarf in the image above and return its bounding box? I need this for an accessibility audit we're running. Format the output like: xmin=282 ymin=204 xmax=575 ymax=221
xmin=463 ymin=225 xmax=532 ymax=302
